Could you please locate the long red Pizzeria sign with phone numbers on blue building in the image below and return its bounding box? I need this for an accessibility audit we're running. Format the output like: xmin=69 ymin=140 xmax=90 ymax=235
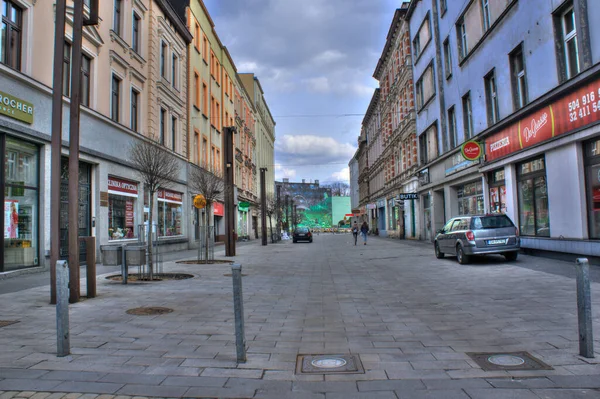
xmin=485 ymin=79 xmax=600 ymax=162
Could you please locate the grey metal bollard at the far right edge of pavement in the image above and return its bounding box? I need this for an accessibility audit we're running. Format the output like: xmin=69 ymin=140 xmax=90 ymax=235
xmin=575 ymin=258 xmax=594 ymax=358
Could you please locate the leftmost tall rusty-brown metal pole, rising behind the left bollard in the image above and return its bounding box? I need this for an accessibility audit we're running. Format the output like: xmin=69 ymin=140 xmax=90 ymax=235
xmin=50 ymin=0 xmax=67 ymax=304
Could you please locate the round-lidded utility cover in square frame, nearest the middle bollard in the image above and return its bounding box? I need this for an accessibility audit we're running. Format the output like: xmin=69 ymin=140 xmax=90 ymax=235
xmin=296 ymin=355 xmax=365 ymax=374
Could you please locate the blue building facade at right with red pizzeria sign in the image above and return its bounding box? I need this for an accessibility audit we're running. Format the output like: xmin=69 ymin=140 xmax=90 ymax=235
xmin=409 ymin=0 xmax=600 ymax=256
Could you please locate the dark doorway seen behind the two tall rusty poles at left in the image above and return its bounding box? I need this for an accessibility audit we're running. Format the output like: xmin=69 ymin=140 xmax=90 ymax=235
xmin=59 ymin=158 xmax=92 ymax=264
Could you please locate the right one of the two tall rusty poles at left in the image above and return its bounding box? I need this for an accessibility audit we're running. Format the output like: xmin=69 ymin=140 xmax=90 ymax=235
xmin=69 ymin=0 xmax=83 ymax=303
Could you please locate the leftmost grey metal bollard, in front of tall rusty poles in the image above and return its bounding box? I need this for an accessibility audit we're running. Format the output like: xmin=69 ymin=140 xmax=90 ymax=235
xmin=56 ymin=260 xmax=71 ymax=357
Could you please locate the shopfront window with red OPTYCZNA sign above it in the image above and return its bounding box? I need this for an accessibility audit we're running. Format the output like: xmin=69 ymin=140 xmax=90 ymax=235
xmin=108 ymin=176 xmax=141 ymax=241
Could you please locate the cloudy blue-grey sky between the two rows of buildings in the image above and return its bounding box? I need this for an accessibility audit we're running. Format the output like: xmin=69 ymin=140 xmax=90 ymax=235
xmin=205 ymin=0 xmax=400 ymax=183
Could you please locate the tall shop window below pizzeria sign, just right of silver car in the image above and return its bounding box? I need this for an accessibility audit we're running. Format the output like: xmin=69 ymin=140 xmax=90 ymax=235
xmin=517 ymin=158 xmax=550 ymax=237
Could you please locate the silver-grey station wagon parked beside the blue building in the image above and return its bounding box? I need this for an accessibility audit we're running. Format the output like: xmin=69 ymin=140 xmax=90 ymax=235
xmin=434 ymin=214 xmax=521 ymax=264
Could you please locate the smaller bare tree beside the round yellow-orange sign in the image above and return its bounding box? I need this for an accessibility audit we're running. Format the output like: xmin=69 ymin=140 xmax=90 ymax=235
xmin=188 ymin=165 xmax=225 ymax=263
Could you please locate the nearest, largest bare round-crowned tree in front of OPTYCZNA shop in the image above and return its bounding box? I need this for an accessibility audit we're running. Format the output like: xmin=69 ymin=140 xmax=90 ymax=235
xmin=129 ymin=140 xmax=180 ymax=281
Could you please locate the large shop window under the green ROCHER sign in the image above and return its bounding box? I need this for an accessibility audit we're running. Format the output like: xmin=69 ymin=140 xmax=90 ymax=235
xmin=0 ymin=138 xmax=39 ymax=272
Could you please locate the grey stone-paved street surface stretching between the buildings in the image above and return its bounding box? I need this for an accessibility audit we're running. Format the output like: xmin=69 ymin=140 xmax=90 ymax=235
xmin=0 ymin=234 xmax=600 ymax=399
